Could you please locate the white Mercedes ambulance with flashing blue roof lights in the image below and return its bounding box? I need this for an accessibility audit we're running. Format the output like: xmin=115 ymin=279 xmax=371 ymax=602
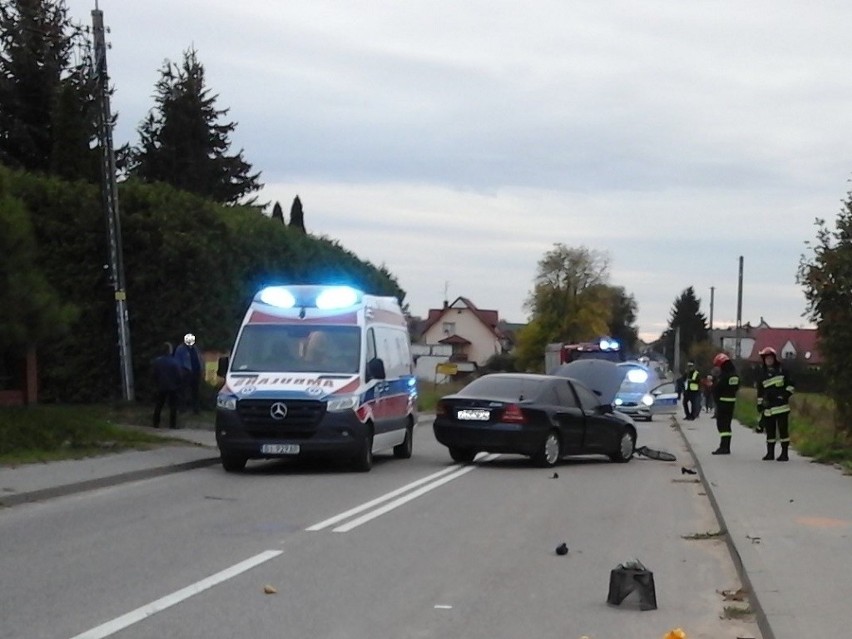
xmin=216 ymin=285 xmax=417 ymax=472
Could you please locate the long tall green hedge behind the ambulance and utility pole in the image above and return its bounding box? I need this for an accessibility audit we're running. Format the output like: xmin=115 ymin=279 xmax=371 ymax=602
xmin=0 ymin=167 xmax=405 ymax=402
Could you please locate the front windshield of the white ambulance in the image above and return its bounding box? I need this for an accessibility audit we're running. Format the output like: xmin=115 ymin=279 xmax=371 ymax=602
xmin=231 ymin=324 xmax=361 ymax=374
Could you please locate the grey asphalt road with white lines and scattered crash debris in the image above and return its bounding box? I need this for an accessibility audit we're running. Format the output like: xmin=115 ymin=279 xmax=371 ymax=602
xmin=0 ymin=418 xmax=760 ymax=639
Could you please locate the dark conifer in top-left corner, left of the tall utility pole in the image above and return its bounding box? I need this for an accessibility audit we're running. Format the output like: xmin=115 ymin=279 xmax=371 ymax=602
xmin=0 ymin=0 xmax=100 ymax=182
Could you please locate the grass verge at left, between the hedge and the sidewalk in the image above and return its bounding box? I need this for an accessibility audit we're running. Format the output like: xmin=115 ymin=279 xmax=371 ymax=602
xmin=0 ymin=405 xmax=184 ymax=465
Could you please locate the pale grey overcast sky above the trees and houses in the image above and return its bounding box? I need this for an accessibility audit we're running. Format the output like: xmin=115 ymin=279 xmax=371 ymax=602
xmin=67 ymin=0 xmax=852 ymax=339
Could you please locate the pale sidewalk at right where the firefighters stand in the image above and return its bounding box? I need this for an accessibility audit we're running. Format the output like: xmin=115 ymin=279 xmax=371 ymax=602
xmin=679 ymin=413 xmax=852 ymax=639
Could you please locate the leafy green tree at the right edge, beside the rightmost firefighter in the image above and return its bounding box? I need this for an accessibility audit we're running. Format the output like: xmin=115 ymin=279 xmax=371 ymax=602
xmin=796 ymin=191 xmax=852 ymax=437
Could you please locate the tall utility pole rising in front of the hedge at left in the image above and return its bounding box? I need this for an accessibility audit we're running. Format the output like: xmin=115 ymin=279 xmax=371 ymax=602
xmin=92 ymin=0 xmax=135 ymax=401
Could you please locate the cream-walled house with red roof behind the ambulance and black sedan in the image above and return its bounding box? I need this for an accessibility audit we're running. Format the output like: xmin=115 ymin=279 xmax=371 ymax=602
xmin=419 ymin=297 xmax=505 ymax=366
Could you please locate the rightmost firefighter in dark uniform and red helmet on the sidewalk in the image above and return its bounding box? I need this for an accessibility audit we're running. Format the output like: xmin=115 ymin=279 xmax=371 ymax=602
xmin=757 ymin=346 xmax=793 ymax=461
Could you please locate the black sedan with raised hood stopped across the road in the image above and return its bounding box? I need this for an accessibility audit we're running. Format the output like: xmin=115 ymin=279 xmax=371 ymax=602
xmin=433 ymin=360 xmax=636 ymax=467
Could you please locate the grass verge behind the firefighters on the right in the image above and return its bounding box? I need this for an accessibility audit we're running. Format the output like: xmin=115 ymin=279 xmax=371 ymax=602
xmin=734 ymin=388 xmax=852 ymax=474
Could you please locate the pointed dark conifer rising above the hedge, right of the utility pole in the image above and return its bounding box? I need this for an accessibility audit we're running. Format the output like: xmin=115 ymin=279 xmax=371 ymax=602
xmin=129 ymin=48 xmax=262 ymax=204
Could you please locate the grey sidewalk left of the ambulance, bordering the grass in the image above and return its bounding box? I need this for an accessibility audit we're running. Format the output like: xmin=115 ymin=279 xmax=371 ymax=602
xmin=0 ymin=427 xmax=219 ymax=508
